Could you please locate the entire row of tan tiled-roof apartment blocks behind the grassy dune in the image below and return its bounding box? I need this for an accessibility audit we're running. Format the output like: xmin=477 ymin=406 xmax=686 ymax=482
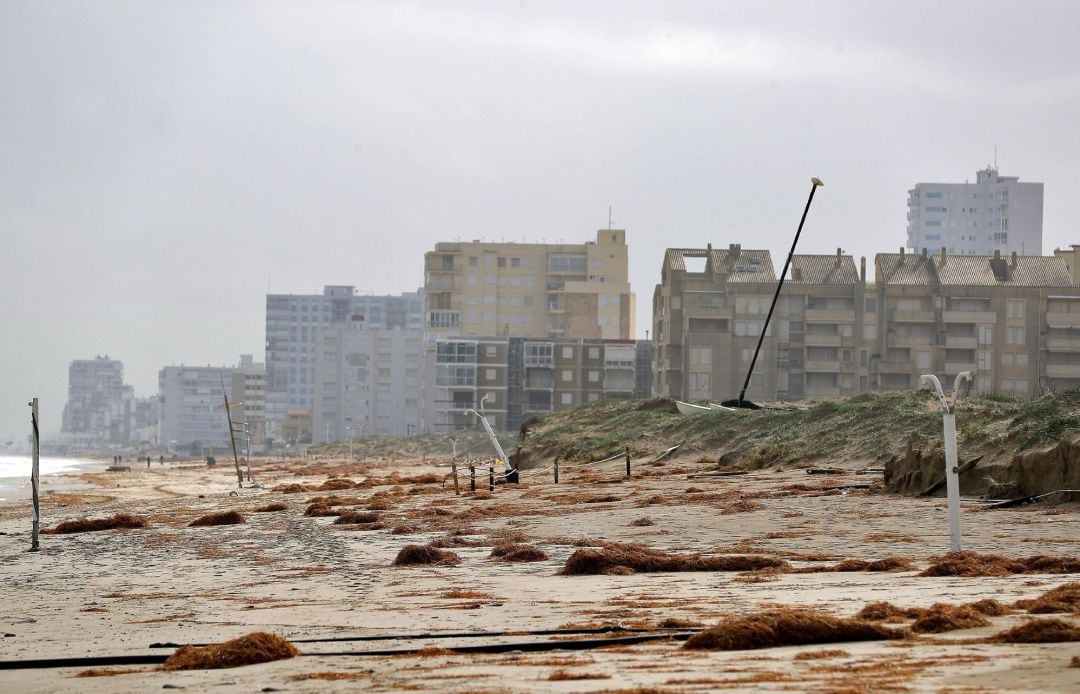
xmin=653 ymin=245 xmax=1080 ymax=400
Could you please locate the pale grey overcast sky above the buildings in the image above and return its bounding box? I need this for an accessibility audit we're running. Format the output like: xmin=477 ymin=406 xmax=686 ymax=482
xmin=0 ymin=0 xmax=1080 ymax=435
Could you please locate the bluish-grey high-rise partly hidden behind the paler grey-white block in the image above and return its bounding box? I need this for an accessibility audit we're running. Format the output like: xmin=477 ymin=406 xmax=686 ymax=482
xmin=266 ymin=286 xmax=423 ymax=438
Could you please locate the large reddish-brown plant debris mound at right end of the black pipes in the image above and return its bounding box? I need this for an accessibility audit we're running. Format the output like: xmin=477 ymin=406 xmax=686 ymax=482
xmin=683 ymin=610 xmax=909 ymax=651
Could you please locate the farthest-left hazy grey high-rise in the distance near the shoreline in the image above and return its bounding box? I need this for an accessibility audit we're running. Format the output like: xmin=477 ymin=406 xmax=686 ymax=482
xmin=60 ymin=356 xmax=134 ymax=448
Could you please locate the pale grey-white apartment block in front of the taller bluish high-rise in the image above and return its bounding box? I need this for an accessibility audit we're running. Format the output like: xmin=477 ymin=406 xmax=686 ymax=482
xmin=312 ymin=321 xmax=423 ymax=443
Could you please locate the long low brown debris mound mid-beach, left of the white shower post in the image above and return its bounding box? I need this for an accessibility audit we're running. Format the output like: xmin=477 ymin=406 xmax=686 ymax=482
xmin=559 ymin=543 xmax=789 ymax=576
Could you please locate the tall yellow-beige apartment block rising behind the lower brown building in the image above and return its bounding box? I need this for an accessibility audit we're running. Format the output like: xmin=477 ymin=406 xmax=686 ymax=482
xmin=424 ymin=229 xmax=634 ymax=339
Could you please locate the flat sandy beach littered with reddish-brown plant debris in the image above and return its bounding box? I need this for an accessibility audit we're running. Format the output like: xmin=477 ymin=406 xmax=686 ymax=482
xmin=0 ymin=458 xmax=1080 ymax=693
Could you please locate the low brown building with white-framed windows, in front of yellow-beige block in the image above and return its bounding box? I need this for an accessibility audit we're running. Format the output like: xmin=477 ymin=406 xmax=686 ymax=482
xmin=424 ymin=337 xmax=652 ymax=433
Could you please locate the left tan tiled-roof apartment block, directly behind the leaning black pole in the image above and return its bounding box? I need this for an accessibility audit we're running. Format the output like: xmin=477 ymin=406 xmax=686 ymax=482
xmin=653 ymin=244 xmax=868 ymax=400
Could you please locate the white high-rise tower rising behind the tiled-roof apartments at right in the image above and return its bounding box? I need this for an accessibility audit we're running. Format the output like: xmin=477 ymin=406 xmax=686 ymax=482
xmin=907 ymin=166 xmax=1042 ymax=256
